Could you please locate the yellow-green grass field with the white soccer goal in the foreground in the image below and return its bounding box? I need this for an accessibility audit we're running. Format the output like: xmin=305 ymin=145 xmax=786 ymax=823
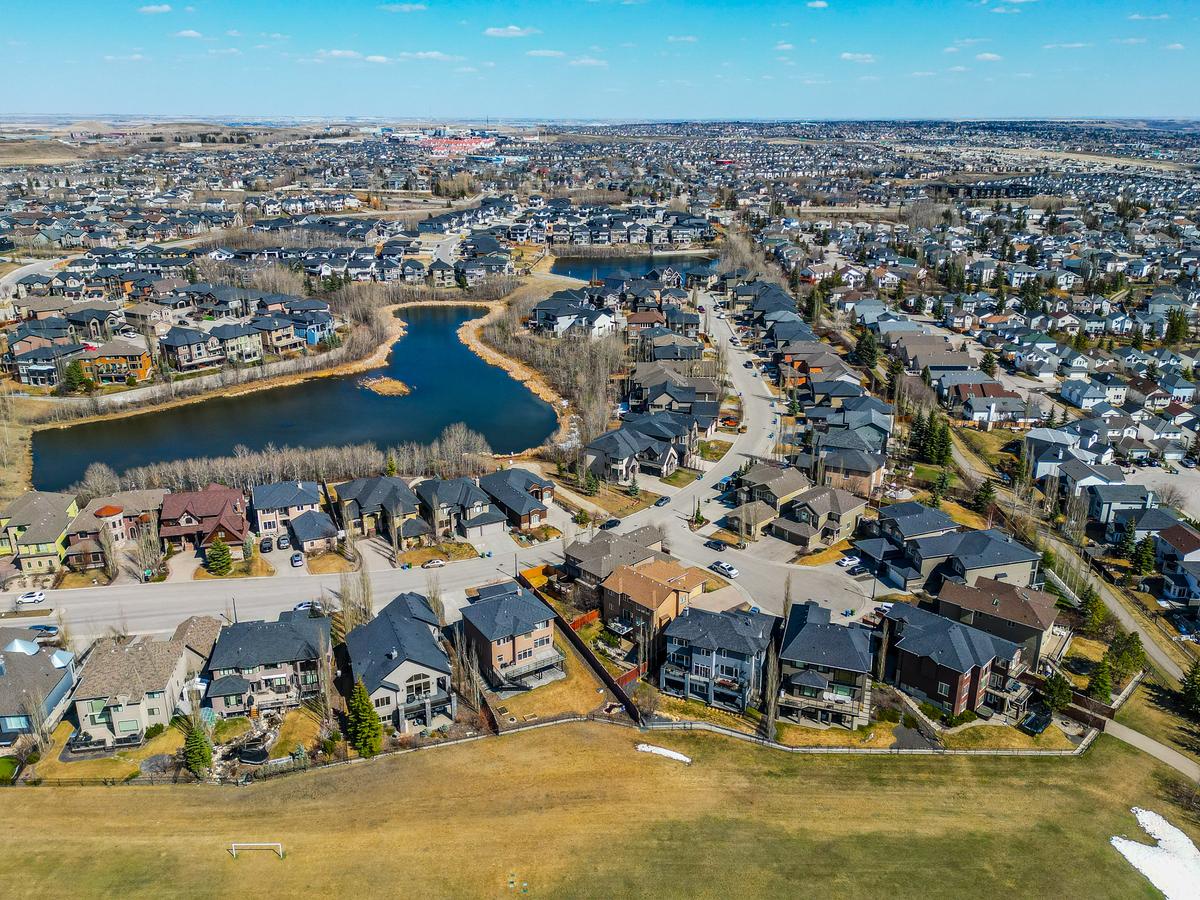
xmin=0 ymin=724 xmax=1200 ymax=900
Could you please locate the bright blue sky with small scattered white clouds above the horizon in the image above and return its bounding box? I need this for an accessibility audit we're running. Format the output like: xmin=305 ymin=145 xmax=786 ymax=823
xmin=0 ymin=0 xmax=1200 ymax=119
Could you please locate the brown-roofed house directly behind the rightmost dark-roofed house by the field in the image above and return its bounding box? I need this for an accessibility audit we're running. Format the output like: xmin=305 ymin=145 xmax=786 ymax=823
xmin=937 ymin=578 xmax=1058 ymax=668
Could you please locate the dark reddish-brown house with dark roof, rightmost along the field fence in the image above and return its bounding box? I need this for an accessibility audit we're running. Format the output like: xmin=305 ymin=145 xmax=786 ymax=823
xmin=876 ymin=604 xmax=1027 ymax=715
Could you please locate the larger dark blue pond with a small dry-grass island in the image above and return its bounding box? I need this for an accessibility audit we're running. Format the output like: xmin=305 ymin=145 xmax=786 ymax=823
xmin=34 ymin=306 xmax=556 ymax=491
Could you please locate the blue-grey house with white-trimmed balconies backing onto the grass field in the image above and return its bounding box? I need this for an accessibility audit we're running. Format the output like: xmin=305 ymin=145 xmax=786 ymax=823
xmin=659 ymin=608 xmax=776 ymax=712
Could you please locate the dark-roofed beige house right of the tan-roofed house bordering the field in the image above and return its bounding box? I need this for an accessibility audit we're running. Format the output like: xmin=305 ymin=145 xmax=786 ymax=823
xmin=208 ymin=610 xmax=332 ymax=718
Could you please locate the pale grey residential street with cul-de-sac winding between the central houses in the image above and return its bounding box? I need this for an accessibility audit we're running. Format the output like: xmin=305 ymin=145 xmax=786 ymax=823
xmin=7 ymin=289 xmax=883 ymax=638
